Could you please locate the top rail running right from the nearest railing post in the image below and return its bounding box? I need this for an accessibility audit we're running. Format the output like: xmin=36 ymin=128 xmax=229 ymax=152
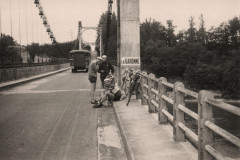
xmin=206 ymin=98 xmax=240 ymax=116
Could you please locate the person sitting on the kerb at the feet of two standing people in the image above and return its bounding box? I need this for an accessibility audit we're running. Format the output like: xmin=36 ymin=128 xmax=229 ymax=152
xmin=93 ymin=77 xmax=122 ymax=108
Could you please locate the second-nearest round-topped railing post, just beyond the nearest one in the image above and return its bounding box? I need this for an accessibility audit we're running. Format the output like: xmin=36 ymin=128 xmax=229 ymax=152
xmin=173 ymin=82 xmax=186 ymax=142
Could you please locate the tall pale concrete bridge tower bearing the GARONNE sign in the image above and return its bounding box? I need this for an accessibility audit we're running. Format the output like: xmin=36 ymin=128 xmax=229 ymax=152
xmin=117 ymin=0 xmax=140 ymax=85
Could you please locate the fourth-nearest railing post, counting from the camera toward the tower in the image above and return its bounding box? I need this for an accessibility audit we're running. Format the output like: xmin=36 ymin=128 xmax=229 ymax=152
xmin=148 ymin=74 xmax=156 ymax=113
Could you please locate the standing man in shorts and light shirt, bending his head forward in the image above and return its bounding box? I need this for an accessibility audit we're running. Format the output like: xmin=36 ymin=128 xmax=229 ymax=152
xmin=88 ymin=57 xmax=102 ymax=104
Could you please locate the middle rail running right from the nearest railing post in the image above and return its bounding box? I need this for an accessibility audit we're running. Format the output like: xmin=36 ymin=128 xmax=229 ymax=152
xmin=204 ymin=121 xmax=240 ymax=147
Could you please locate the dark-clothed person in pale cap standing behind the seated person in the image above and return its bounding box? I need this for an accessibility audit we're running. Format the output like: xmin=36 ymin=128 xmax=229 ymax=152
xmin=98 ymin=55 xmax=114 ymax=88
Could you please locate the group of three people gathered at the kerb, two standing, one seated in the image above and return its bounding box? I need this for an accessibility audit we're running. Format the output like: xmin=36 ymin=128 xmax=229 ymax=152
xmin=88 ymin=55 xmax=121 ymax=108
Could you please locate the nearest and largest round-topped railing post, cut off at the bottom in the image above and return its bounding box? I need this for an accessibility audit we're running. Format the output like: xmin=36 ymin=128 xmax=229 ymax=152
xmin=198 ymin=90 xmax=214 ymax=160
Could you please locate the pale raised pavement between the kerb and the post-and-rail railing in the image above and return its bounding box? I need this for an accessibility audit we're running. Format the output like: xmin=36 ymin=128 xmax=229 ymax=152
xmin=114 ymin=100 xmax=197 ymax=160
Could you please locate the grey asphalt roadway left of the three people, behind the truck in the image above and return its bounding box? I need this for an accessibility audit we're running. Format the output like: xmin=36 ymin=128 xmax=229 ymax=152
xmin=0 ymin=71 xmax=105 ymax=160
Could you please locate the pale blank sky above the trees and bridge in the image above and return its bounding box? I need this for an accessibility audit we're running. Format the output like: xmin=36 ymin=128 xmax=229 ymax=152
xmin=0 ymin=0 xmax=240 ymax=45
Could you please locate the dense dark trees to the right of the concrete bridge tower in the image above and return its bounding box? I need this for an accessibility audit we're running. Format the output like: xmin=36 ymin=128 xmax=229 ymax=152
xmin=140 ymin=15 xmax=240 ymax=99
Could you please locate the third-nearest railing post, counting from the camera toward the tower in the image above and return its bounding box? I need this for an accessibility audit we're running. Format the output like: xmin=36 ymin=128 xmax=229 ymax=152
xmin=158 ymin=77 xmax=167 ymax=124
